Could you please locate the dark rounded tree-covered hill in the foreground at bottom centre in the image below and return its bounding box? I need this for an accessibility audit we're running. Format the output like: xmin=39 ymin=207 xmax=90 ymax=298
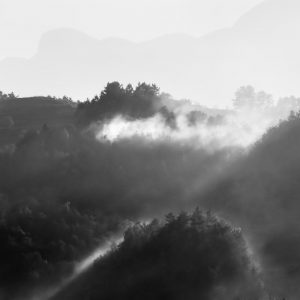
xmin=55 ymin=209 xmax=262 ymax=300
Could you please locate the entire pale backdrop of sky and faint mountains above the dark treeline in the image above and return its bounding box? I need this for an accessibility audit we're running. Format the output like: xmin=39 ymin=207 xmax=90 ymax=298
xmin=0 ymin=0 xmax=300 ymax=108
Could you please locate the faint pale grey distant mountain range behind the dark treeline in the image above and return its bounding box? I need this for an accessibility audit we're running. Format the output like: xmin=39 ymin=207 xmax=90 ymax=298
xmin=0 ymin=0 xmax=300 ymax=106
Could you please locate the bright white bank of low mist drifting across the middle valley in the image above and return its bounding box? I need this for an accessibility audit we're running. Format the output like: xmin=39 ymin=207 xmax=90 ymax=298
xmin=92 ymin=108 xmax=284 ymax=150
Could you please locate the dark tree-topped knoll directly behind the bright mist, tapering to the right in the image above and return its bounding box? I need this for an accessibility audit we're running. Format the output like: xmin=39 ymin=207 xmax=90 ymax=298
xmin=76 ymin=82 xmax=223 ymax=129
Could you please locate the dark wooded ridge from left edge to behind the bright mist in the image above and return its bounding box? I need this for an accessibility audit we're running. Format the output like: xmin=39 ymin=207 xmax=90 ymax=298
xmin=0 ymin=82 xmax=224 ymax=147
